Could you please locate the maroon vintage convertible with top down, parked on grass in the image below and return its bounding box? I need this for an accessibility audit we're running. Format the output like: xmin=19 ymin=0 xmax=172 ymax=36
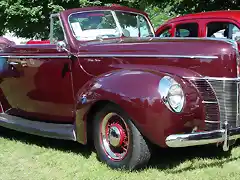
xmin=0 ymin=6 xmax=240 ymax=169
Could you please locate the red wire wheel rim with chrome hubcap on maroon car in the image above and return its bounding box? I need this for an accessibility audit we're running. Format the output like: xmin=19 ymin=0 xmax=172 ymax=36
xmin=100 ymin=113 xmax=129 ymax=161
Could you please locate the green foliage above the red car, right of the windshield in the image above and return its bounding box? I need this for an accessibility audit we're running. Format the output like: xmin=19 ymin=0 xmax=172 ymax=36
xmin=146 ymin=0 xmax=240 ymax=27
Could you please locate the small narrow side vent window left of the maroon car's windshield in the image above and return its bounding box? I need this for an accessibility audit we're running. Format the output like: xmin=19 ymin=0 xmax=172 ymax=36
xmin=51 ymin=17 xmax=64 ymax=44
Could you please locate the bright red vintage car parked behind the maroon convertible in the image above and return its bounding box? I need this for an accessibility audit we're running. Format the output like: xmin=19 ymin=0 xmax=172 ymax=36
xmin=156 ymin=10 xmax=240 ymax=40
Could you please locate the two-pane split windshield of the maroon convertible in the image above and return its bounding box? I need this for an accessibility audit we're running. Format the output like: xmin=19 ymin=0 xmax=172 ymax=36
xmin=69 ymin=11 xmax=154 ymax=41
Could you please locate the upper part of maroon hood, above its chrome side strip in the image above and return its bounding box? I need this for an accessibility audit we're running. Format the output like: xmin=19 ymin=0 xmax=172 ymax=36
xmin=79 ymin=38 xmax=229 ymax=56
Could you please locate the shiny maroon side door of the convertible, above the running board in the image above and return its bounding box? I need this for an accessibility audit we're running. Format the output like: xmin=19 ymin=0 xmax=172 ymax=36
xmin=0 ymin=44 xmax=74 ymax=122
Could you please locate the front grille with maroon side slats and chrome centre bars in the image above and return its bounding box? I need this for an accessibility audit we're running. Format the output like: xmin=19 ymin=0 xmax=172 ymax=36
xmin=193 ymin=79 xmax=239 ymax=130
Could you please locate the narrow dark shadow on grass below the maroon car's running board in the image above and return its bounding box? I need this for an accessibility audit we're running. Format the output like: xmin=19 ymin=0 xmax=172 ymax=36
xmin=0 ymin=127 xmax=94 ymax=158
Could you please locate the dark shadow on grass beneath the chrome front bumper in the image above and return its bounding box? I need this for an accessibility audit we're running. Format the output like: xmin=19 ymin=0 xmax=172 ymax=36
xmin=149 ymin=141 xmax=240 ymax=174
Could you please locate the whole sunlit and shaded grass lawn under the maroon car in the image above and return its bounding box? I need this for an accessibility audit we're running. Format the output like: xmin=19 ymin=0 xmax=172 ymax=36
xmin=0 ymin=128 xmax=240 ymax=180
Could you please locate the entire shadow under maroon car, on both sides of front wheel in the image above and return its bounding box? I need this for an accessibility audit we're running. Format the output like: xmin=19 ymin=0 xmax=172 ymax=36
xmin=0 ymin=127 xmax=240 ymax=174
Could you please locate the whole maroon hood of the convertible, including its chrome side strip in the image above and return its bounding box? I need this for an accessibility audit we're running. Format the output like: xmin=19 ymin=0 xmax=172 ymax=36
xmin=78 ymin=38 xmax=236 ymax=77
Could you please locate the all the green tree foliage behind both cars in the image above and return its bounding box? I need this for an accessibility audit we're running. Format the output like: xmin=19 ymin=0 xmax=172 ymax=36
xmin=0 ymin=0 xmax=240 ymax=38
